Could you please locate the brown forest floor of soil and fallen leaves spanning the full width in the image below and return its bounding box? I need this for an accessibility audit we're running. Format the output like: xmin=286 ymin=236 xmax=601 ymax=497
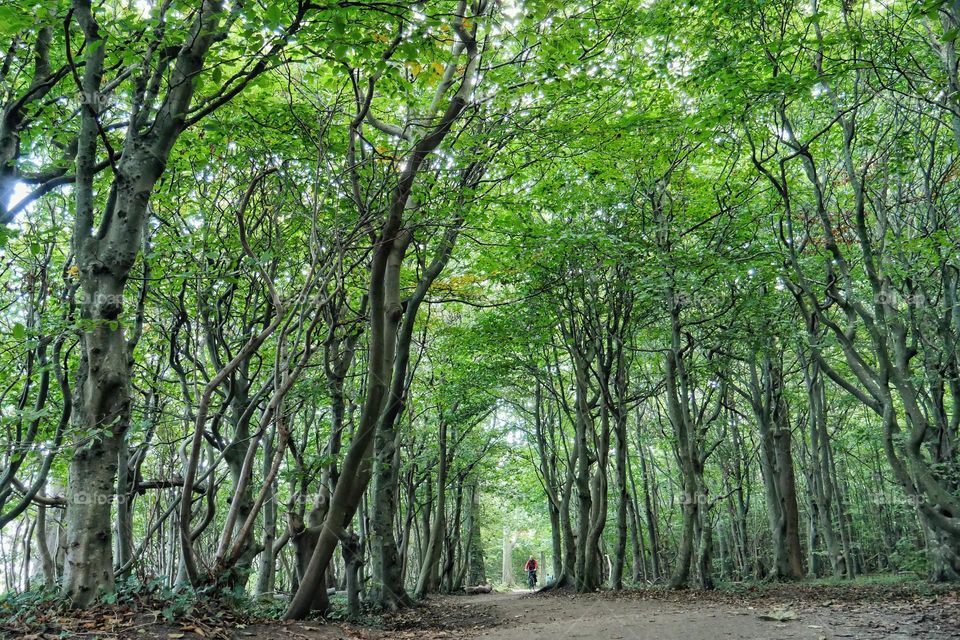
xmin=0 ymin=584 xmax=960 ymax=640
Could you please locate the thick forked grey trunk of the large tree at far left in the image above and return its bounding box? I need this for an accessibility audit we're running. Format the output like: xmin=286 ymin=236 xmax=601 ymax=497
xmin=63 ymin=0 xmax=229 ymax=607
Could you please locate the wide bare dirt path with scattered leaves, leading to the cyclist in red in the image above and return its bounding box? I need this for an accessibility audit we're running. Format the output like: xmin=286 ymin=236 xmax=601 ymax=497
xmin=378 ymin=591 xmax=960 ymax=640
